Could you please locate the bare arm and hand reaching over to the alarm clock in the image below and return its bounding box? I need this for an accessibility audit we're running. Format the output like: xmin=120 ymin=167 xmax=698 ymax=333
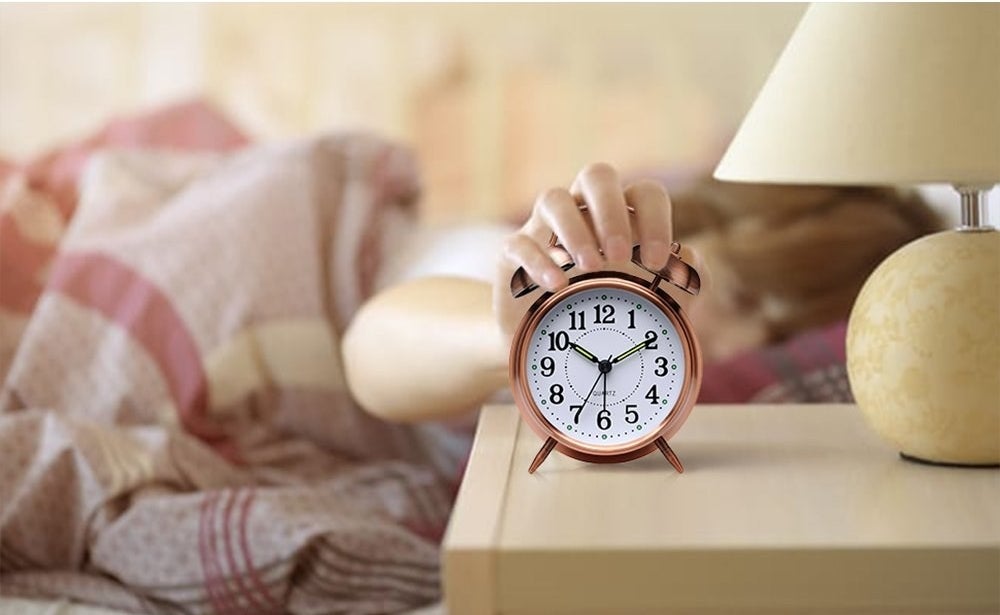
xmin=343 ymin=164 xmax=671 ymax=421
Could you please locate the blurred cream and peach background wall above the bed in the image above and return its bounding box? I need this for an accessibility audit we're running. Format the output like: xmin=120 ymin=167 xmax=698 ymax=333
xmin=0 ymin=4 xmax=805 ymax=221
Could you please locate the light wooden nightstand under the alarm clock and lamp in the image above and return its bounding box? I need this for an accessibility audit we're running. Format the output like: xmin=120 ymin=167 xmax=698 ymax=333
xmin=444 ymin=405 xmax=1000 ymax=615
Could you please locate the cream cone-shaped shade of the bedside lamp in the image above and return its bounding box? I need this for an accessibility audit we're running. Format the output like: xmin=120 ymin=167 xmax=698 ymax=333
xmin=715 ymin=4 xmax=1000 ymax=185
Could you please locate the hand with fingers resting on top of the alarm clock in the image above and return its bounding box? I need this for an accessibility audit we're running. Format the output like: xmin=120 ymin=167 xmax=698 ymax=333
xmin=493 ymin=163 xmax=684 ymax=339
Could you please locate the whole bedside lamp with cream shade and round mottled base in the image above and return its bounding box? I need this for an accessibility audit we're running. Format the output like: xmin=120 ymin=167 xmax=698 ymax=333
xmin=715 ymin=4 xmax=1000 ymax=466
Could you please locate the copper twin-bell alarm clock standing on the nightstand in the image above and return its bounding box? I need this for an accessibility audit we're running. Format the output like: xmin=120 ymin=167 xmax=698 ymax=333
xmin=509 ymin=224 xmax=701 ymax=473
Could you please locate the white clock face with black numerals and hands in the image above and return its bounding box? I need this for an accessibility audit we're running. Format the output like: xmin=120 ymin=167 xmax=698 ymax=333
xmin=524 ymin=287 xmax=686 ymax=447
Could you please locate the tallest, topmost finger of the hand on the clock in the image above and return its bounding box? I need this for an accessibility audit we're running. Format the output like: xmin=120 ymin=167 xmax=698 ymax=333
xmin=573 ymin=163 xmax=632 ymax=263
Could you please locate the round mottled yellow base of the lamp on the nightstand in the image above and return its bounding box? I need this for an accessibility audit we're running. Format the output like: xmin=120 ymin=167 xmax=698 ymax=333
xmin=847 ymin=231 xmax=1000 ymax=466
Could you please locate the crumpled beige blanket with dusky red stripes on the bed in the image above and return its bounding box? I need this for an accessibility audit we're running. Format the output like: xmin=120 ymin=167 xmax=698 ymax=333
xmin=0 ymin=108 xmax=468 ymax=614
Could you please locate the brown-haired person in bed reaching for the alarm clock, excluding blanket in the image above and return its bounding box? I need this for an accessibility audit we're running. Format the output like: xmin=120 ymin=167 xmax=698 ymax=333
xmin=343 ymin=163 xmax=939 ymax=421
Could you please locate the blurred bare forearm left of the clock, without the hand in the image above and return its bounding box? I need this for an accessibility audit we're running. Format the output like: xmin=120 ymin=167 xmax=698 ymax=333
xmin=343 ymin=278 xmax=507 ymax=421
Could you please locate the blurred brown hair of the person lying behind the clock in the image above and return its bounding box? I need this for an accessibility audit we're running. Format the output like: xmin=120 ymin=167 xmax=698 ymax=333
xmin=672 ymin=178 xmax=942 ymax=342
